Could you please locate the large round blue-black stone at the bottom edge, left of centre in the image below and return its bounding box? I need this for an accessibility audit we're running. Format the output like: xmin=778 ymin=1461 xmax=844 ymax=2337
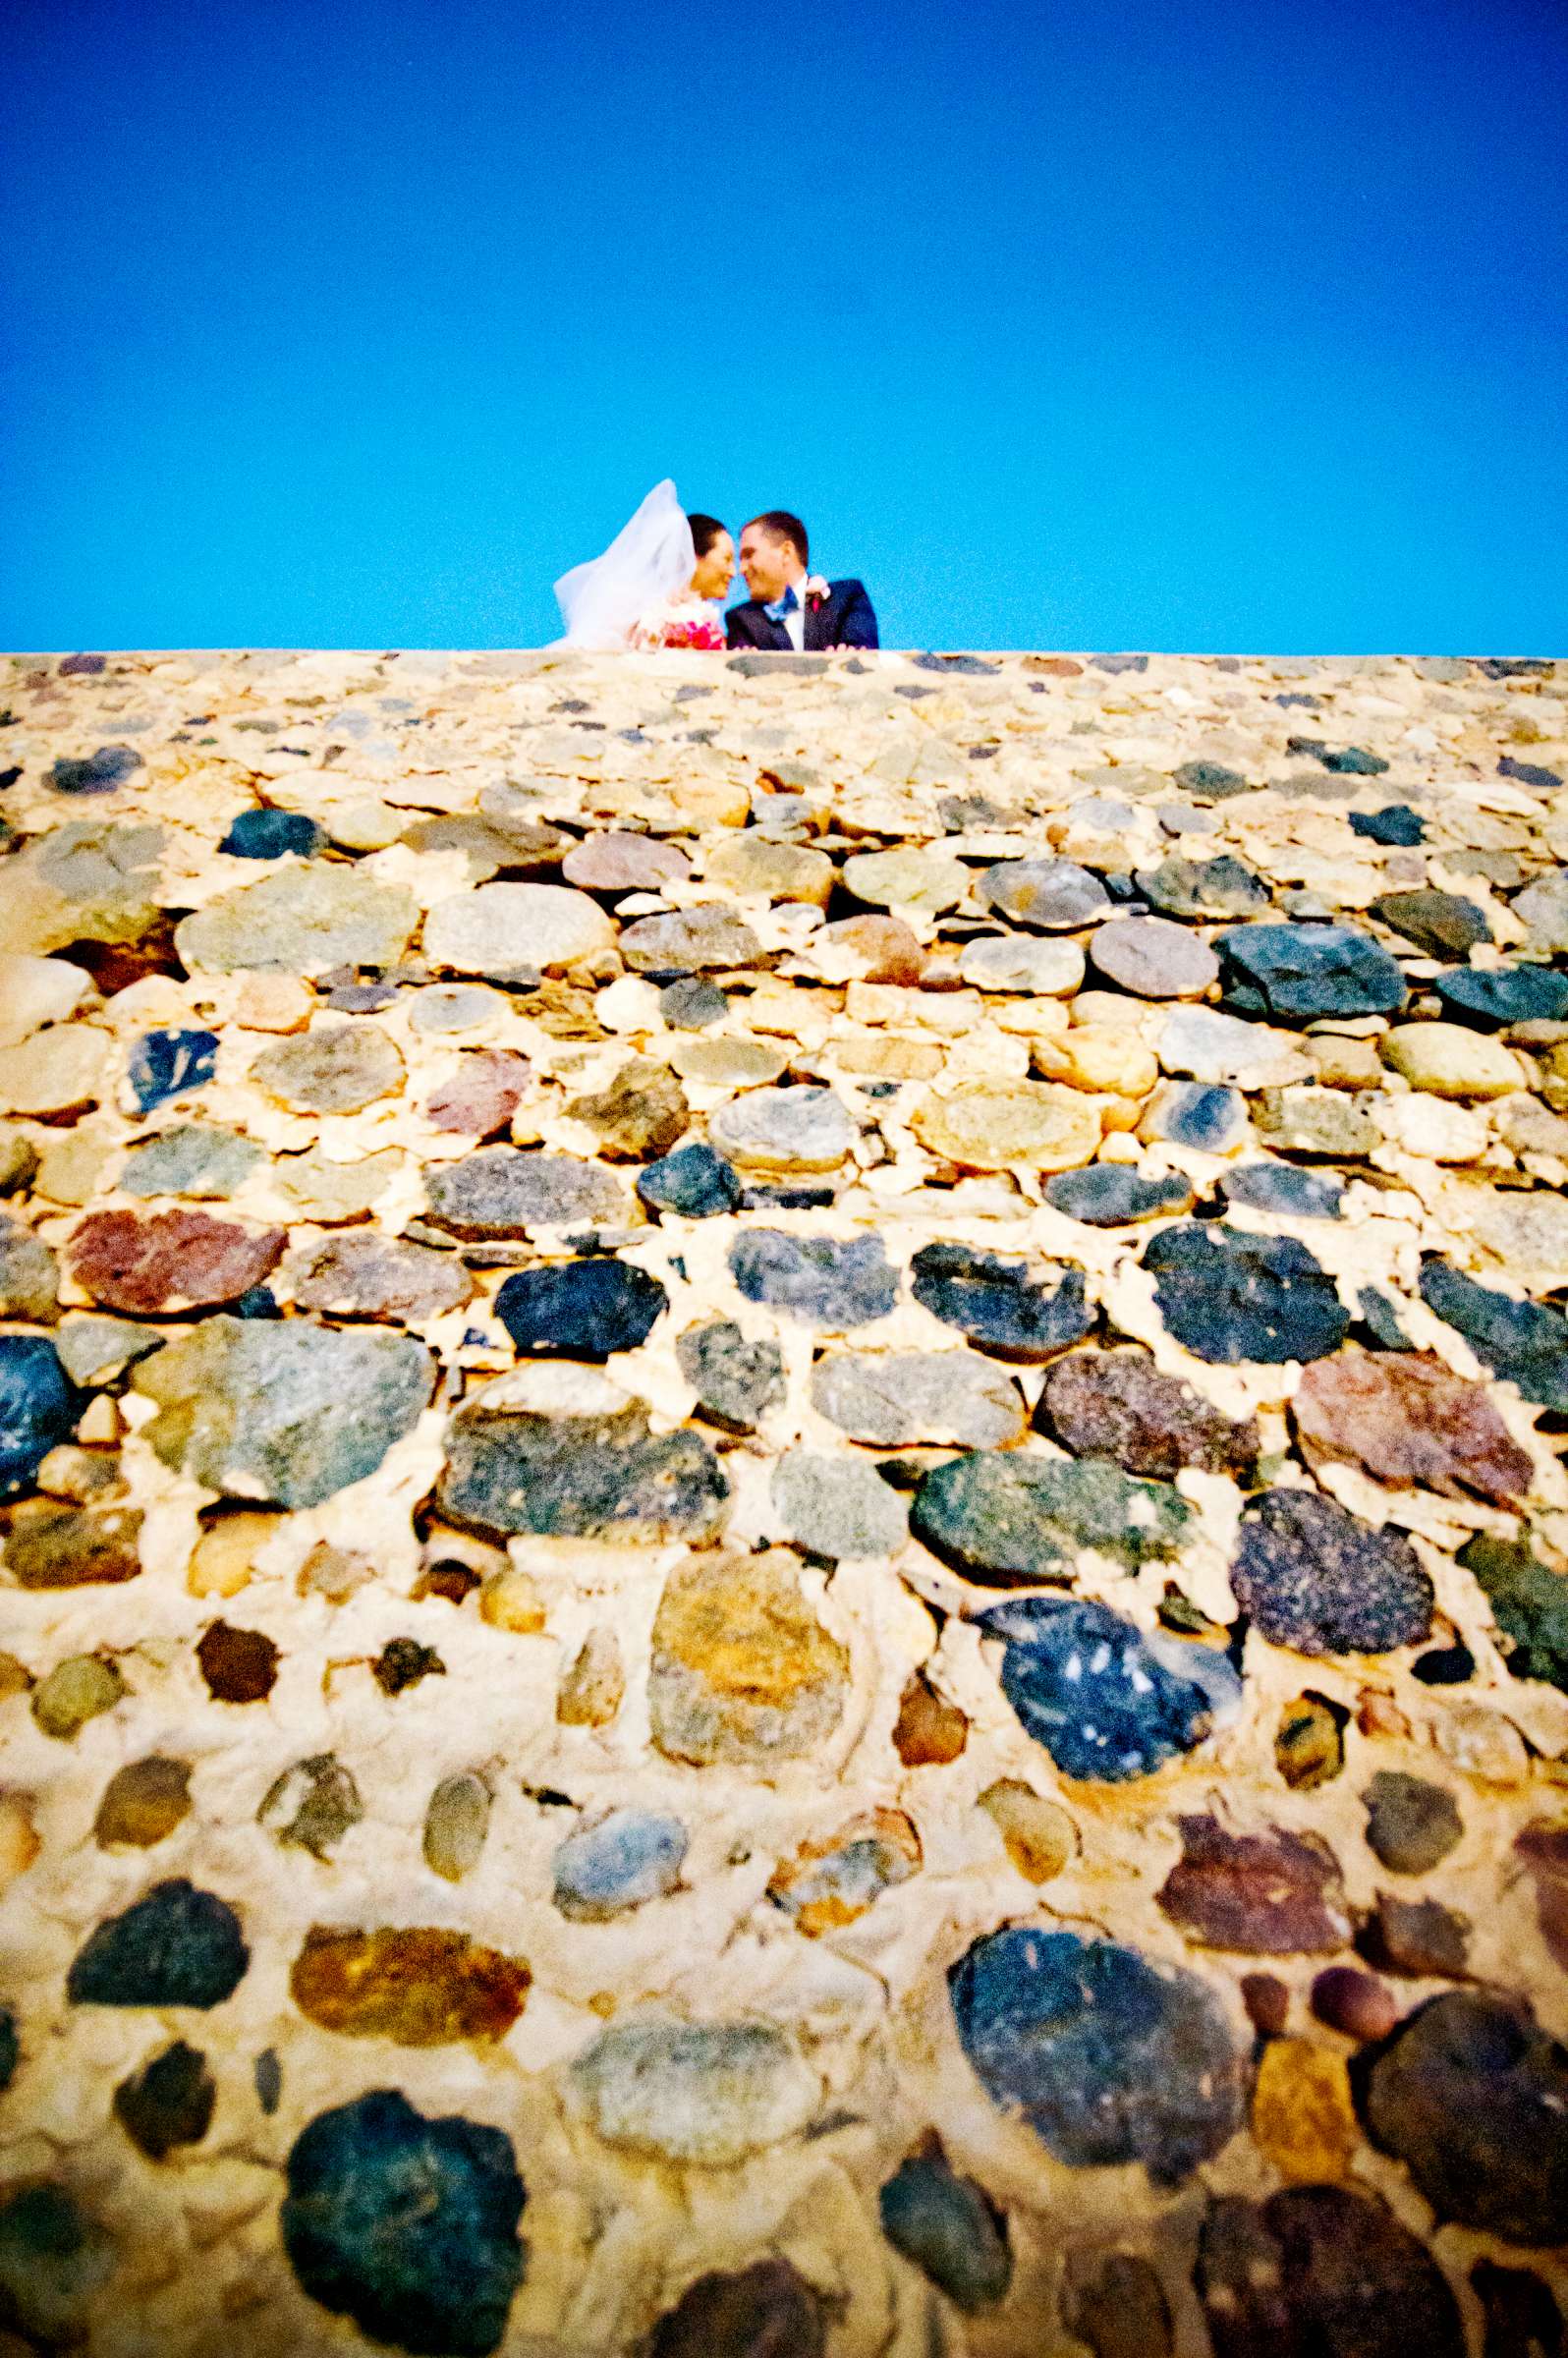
xmin=278 ymin=2089 xmax=526 ymax=2358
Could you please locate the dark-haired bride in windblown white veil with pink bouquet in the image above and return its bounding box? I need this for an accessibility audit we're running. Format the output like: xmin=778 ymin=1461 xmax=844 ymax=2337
xmin=554 ymin=481 xmax=736 ymax=650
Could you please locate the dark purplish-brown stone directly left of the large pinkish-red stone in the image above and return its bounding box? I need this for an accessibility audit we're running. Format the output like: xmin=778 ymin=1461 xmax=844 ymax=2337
xmin=1039 ymin=1344 xmax=1260 ymax=1481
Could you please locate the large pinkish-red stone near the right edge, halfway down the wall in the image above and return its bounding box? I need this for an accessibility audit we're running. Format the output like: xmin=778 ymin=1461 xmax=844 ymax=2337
xmin=1292 ymin=1351 xmax=1533 ymax=1507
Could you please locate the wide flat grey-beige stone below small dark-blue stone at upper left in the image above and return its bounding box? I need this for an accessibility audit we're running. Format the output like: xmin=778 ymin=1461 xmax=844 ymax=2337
xmin=175 ymin=861 xmax=420 ymax=974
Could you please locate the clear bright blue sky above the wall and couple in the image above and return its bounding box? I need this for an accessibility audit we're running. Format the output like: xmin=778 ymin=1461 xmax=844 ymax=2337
xmin=0 ymin=0 xmax=1568 ymax=653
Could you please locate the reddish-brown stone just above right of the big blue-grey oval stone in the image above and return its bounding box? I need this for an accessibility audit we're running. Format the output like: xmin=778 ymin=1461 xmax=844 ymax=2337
xmin=1157 ymin=1816 xmax=1351 ymax=1957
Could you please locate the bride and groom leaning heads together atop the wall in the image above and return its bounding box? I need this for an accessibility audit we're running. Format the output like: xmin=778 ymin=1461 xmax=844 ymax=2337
xmin=554 ymin=481 xmax=877 ymax=653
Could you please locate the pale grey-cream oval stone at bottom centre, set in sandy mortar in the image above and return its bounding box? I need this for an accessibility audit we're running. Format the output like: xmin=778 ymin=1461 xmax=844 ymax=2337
xmin=571 ymin=2018 xmax=818 ymax=2160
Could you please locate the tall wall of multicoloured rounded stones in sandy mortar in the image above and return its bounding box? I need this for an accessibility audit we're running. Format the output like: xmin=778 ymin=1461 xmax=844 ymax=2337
xmin=0 ymin=653 xmax=1568 ymax=2358
